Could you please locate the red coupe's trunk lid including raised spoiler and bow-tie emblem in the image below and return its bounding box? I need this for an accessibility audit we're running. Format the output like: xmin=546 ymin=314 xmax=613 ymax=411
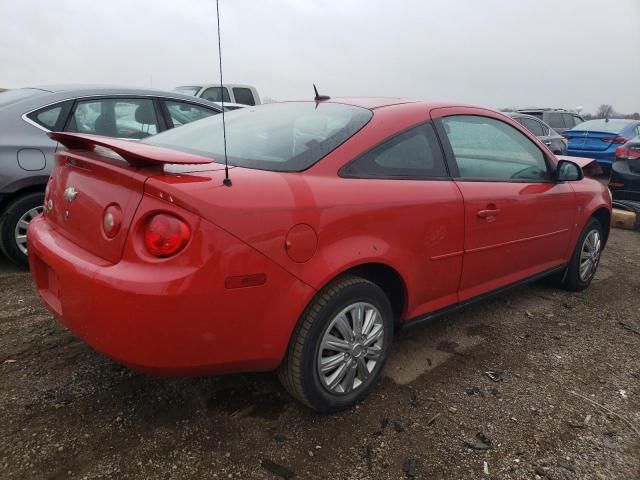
xmin=45 ymin=133 xmax=211 ymax=263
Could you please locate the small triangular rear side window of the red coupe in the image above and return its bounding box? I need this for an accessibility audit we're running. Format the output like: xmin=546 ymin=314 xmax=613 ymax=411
xmin=340 ymin=123 xmax=447 ymax=178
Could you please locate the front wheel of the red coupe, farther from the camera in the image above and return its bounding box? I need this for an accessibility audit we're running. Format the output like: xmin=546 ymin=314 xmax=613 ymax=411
xmin=564 ymin=218 xmax=604 ymax=292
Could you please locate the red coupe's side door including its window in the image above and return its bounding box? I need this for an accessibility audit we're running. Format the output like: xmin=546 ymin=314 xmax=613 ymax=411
xmin=431 ymin=108 xmax=575 ymax=301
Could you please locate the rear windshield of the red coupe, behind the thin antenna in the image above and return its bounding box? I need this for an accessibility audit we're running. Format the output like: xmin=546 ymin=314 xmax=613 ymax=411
xmin=144 ymin=102 xmax=373 ymax=172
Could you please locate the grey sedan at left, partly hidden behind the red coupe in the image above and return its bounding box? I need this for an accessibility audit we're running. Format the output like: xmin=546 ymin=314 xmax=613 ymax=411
xmin=0 ymin=86 xmax=222 ymax=265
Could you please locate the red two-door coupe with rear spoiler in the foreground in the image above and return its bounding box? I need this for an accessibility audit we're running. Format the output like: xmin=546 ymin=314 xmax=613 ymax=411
xmin=28 ymin=99 xmax=611 ymax=412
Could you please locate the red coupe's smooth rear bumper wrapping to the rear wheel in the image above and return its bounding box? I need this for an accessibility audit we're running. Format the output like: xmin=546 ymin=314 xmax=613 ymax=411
xmin=28 ymin=213 xmax=314 ymax=375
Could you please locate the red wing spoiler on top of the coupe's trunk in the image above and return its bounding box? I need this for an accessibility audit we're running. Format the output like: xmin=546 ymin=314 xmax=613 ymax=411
xmin=48 ymin=132 xmax=213 ymax=167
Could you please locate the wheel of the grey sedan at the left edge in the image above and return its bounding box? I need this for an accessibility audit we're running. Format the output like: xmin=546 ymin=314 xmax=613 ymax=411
xmin=0 ymin=193 xmax=44 ymax=268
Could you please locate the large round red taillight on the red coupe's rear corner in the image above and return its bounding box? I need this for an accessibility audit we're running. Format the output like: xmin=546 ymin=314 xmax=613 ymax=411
xmin=144 ymin=213 xmax=191 ymax=257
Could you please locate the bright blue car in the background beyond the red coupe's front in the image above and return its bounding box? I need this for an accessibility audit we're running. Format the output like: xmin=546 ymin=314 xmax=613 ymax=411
xmin=562 ymin=118 xmax=640 ymax=170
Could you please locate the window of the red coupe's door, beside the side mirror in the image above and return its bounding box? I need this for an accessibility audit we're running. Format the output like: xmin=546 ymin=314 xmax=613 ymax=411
xmin=442 ymin=115 xmax=549 ymax=181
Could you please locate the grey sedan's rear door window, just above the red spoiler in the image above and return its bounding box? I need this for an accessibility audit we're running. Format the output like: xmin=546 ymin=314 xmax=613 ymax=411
xmin=67 ymin=98 xmax=158 ymax=139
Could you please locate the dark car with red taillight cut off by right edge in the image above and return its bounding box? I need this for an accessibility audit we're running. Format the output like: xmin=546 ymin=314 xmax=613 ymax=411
xmin=609 ymin=136 xmax=640 ymax=202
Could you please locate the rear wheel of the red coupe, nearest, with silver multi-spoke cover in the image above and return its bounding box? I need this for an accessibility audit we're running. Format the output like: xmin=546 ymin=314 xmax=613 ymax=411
xmin=278 ymin=275 xmax=393 ymax=413
